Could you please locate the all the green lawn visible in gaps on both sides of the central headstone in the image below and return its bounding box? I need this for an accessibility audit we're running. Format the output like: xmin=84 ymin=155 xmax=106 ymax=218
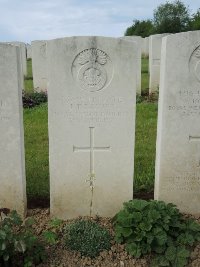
xmin=24 ymin=59 xmax=157 ymax=200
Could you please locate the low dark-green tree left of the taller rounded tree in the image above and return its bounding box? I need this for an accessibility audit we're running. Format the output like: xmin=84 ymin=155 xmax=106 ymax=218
xmin=124 ymin=20 xmax=154 ymax=37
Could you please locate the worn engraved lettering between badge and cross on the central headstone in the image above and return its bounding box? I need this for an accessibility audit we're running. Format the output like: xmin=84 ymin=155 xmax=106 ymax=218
xmin=53 ymin=96 xmax=130 ymax=124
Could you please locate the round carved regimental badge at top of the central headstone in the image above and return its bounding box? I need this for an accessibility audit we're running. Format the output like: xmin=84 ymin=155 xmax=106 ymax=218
xmin=72 ymin=48 xmax=113 ymax=92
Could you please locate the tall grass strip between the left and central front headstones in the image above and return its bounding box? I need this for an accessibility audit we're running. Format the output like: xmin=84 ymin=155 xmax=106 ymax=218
xmin=24 ymin=104 xmax=49 ymax=198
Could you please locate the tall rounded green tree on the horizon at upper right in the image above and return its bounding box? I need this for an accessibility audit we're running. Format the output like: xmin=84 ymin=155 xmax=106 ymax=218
xmin=153 ymin=0 xmax=191 ymax=33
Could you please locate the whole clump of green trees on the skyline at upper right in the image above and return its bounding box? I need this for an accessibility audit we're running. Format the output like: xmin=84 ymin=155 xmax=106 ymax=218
xmin=124 ymin=0 xmax=200 ymax=37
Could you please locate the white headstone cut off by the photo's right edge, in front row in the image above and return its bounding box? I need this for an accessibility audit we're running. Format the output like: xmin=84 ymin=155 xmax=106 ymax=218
xmin=155 ymin=31 xmax=200 ymax=214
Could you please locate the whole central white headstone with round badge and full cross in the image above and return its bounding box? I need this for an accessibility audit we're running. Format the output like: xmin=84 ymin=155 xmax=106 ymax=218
xmin=47 ymin=37 xmax=137 ymax=219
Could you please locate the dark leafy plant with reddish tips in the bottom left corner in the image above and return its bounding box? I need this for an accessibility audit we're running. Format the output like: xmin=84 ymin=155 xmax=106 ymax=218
xmin=0 ymin=211 xmax=45 ymax=267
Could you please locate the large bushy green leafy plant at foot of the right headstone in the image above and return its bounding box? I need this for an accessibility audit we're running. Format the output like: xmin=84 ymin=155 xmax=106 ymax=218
xmin=113 ymin=199 xmax=200 ymax=267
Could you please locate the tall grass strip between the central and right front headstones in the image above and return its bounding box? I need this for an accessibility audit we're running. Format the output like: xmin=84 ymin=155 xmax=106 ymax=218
xmin=134 ymin=103 xmax=158 ymax=192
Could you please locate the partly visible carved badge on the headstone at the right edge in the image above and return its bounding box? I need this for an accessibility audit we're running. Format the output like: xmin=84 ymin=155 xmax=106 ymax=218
xmin=189 ymin=46 xmax=200 ymax=82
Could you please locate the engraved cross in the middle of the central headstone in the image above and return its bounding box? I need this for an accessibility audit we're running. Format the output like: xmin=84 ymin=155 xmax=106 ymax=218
xmin=73 ymin=127 xmax=110 ymax=187
